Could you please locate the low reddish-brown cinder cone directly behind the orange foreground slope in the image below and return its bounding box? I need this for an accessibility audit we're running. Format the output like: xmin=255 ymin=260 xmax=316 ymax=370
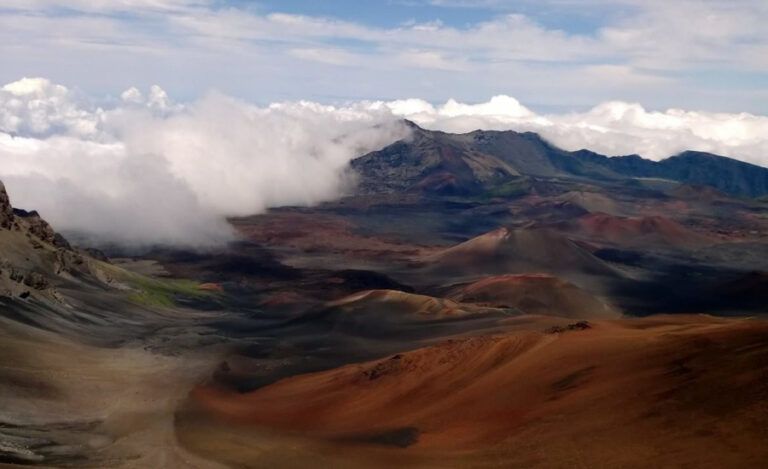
xmin=450 ymin=274 xmax=621 ymax=319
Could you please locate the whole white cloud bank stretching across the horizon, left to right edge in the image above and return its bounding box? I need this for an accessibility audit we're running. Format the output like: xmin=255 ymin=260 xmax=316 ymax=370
xmin=0 ymin=78 xmax=768 ymax=246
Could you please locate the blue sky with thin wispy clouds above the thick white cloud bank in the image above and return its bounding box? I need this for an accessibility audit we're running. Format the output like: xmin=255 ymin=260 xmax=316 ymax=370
xmin=0 ymin=0 xmax=768 ymax=114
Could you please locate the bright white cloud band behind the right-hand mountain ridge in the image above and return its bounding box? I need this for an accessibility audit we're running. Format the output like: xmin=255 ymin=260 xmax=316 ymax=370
xmin=388 ymin=96 xmax=768 ymax=166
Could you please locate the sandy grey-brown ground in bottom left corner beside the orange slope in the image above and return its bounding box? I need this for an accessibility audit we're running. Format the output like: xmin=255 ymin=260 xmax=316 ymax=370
xmin=0 ymin=314 xmax=231 ymax=468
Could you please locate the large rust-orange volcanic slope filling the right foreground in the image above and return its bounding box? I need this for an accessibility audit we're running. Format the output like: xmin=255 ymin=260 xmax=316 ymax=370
xmin=192 ymin=315 xmax=768 ymax=467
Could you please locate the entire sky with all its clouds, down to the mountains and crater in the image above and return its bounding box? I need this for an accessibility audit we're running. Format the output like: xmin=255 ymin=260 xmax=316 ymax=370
xmin=0 ymin=0 xmax=768 ymax=247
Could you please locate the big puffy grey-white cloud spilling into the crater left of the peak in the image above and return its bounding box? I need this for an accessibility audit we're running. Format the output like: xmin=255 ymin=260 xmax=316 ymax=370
xmin=0 ymin=80 xmax=406 ymax=245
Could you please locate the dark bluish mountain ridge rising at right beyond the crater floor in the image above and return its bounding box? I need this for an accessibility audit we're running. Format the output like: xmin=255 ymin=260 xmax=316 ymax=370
xmin=351 ymin=121 xmax=768 ymax=198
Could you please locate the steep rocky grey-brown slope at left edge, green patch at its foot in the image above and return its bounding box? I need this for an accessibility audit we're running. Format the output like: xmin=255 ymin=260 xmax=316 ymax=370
xmin=0 ymin=184 xmax=222 ymax=345
